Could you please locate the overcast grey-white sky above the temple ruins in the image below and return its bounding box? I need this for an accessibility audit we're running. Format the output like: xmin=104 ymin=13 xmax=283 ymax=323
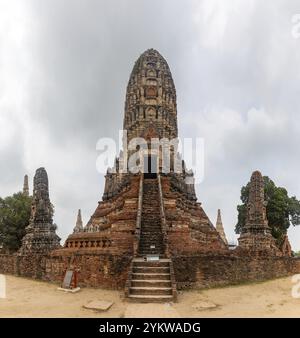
xmin=0 ymin=0 xmax=300 ymax=250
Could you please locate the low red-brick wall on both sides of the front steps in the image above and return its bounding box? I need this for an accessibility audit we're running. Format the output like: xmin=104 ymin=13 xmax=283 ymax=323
xmin=0 ymin=252 xmax=300 ymax=289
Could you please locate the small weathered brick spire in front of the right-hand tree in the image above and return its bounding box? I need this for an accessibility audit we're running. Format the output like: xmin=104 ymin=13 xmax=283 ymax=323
xmin=239 ymin=171 xmax=280 ymax=255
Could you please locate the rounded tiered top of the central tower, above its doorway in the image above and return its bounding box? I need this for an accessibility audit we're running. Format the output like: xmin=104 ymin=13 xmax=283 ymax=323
xmin=124 ymin=49 xmax=177 ymax=141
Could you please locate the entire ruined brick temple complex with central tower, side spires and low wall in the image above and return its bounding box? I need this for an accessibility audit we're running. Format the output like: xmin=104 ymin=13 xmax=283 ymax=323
xmin=0 ymin=49 xmax=300 ymax=302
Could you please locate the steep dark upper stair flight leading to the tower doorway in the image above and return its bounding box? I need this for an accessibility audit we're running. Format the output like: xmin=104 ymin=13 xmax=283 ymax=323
xmin=138 ymin=178 xmax=164 ymax=256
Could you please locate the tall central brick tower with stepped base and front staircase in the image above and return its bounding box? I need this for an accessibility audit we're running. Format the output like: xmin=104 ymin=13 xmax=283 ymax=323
xmin=64 ymin=49 xmax=227 ymax=299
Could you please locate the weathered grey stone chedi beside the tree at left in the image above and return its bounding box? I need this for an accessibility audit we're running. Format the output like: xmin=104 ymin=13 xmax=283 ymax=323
xmin=20 ymin=168 xmax=60 ymax=255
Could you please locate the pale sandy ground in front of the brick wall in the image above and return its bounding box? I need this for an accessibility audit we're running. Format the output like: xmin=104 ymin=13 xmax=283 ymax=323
xmin=0 ymin=276 xmax=300 ymax=318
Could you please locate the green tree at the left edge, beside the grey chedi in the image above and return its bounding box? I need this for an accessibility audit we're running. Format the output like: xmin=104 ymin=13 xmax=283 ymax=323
xmin=0 ymin=192 xmax=31 ymax=252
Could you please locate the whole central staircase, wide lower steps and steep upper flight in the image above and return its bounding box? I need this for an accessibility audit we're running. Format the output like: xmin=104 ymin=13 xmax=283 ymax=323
xmin=125 ymin=178 xmax=177 ymax=303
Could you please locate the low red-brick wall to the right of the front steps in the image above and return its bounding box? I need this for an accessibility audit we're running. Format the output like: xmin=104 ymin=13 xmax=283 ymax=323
xmin=173 ymin=254 xmax=300 ymax=289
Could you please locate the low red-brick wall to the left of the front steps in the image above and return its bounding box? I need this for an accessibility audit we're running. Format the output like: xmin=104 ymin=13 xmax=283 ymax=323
xmin=0 ymin=253 xmax=132 ymax=289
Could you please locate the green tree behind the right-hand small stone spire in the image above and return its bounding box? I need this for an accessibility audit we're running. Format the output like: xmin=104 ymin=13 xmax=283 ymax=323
xmin=235 ymin=176 xmax=300 ymax=246
